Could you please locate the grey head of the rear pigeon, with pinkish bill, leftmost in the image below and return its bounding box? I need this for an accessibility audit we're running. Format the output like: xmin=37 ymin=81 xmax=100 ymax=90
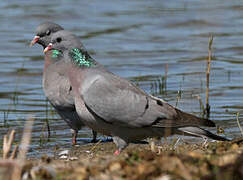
xmin=30 ymin=22 xmax=63 ymax=48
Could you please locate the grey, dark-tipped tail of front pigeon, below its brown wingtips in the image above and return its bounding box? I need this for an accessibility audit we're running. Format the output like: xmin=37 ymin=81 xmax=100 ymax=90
xmin=178 ymin=127 xmax=230 ymax=141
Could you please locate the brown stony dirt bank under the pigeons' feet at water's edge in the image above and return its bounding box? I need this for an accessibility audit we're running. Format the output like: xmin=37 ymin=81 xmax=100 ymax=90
xmin=5 ymin=138 xmax=243 ymax=180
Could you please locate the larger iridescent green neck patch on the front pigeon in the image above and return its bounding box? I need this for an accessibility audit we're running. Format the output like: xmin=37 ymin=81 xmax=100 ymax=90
xmin=69 ymin=48 xmax=95 ymax=67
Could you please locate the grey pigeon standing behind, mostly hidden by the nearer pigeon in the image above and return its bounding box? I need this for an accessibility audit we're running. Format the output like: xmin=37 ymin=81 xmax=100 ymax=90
xmin=30 ymin=22 xmax=97 ymax=145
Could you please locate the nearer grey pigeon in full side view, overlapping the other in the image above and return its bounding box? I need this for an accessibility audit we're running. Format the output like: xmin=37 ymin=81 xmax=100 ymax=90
xmin=44 ymin=31 xmax=227 ymax=154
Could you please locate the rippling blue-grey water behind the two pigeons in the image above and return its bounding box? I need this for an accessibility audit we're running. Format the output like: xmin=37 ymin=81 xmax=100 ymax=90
xmin=0 ymin=0 xmax=243 ymax=156
